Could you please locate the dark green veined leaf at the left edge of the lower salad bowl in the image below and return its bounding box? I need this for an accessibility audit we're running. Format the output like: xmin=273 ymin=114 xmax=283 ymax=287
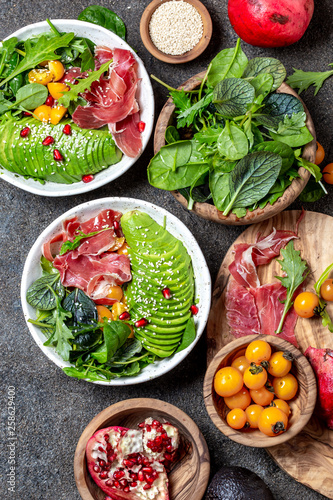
xmin=26 ymin=271 xmax=65 ymax=311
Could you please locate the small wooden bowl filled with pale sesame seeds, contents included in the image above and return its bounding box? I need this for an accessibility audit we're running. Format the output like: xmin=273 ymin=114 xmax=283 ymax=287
xmin=140 ymin=0 xmax=212 ymax=64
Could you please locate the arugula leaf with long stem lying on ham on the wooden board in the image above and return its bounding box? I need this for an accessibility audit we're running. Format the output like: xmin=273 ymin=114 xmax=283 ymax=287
xmin=275 ymin=241 xmax=309 ymax=334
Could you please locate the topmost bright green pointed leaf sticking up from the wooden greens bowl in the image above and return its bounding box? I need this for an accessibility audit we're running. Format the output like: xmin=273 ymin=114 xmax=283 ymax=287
xmin=207 ymin=38 xmax=248 ymax=87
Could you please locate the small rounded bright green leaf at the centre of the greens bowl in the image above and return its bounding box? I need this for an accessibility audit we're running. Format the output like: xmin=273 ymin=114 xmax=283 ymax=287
xmin=217 ymin=120 xmax=249 ymax=161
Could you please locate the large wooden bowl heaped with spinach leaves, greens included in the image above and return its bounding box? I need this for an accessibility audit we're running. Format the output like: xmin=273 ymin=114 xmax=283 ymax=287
xmin=148 ymin=41 xmax=320 ymax=225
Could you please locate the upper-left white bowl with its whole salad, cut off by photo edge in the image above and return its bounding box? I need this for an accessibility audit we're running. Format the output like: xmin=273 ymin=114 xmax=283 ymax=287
xmin=0 ymin=19 xmax=154 ymax=196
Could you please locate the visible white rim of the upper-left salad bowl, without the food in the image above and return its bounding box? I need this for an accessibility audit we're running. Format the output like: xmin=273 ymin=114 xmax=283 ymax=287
xmin=0 ymin=19 xmax=154 ymax=196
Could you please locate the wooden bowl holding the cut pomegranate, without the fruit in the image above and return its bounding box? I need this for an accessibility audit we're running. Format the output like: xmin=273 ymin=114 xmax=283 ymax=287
xmin=74 ymin=398 xmax=210 ymax=500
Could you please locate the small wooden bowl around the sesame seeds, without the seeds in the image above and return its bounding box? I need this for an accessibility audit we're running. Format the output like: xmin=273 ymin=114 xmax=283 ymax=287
xmin=140 ymin=0 xmax=213 ymax=64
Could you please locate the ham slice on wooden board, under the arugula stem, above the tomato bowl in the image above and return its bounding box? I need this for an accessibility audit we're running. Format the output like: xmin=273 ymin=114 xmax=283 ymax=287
xmin=250 ymin=282 xmax=298 ymax=347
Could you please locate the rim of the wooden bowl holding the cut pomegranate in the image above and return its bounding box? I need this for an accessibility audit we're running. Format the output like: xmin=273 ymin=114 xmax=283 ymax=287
xmin=74 ymin=398 xmax=210 ymax=500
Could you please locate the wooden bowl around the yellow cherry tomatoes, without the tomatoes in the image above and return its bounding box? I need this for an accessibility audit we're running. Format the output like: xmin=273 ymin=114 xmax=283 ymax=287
xmin=203 ymin=335 xmax=317 ymax=448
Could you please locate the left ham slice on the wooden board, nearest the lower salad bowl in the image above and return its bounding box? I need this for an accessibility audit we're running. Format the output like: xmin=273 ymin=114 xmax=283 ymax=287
xmin=226 ymin=278 xmax=260 ymax=338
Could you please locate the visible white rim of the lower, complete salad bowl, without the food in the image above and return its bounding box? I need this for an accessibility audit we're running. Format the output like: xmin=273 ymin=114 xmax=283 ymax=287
xmin=21 ymin=198 xmax=211 ymax=386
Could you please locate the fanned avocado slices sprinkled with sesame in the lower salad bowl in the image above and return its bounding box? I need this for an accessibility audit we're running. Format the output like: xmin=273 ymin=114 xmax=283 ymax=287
xmin=121 ymin=210 xmax=194 ymax=357
